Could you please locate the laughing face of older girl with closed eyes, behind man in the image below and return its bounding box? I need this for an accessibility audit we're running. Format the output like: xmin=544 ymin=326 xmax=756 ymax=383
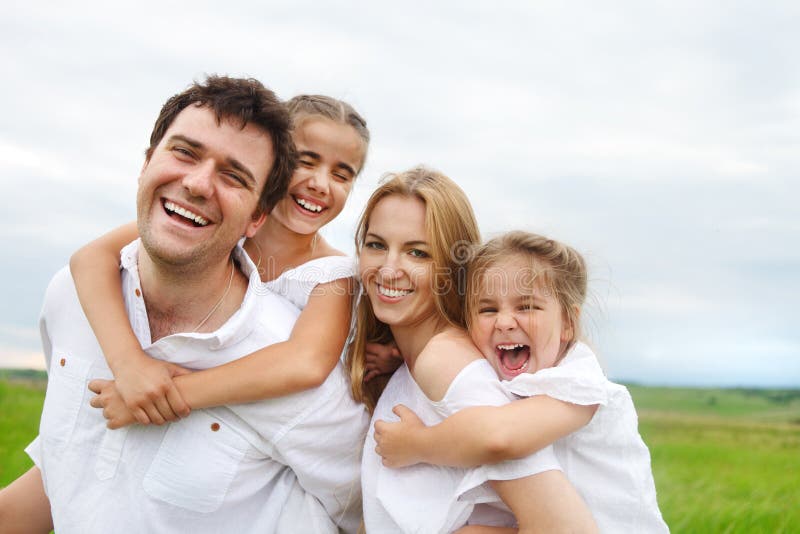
xmin=270 ymin=116 xmax=364 ymax=235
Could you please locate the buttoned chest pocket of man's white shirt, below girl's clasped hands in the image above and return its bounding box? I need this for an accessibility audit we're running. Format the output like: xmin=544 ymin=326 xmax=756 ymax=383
xmin=143 ymin=410 xmax=250 ymax=513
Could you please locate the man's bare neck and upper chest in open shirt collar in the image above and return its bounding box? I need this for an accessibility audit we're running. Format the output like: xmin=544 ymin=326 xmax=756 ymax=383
xmin=139 ymin=248 xmax=247 ymax=342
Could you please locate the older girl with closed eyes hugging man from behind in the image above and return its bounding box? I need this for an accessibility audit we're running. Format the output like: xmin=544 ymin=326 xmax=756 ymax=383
xmin=70 ymin=95 xmax=381 ymax=428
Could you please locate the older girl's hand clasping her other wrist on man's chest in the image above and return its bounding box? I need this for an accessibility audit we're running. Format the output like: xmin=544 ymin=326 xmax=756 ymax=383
xmin=114 ymin=352 xmax=191 ymax=425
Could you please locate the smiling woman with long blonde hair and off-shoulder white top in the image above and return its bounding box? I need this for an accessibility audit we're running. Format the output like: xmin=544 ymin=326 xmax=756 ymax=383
xmin=348 ymin=172 xmax=595 ymax=534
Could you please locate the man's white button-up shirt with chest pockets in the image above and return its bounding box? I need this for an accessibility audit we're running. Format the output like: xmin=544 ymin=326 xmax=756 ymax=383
xmin=26 ymin=242 xmax=368 ymax=534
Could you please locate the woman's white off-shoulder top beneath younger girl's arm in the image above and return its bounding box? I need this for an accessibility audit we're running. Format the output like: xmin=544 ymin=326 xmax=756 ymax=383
xmin=361 ymin=359 xmax=560 ymax=534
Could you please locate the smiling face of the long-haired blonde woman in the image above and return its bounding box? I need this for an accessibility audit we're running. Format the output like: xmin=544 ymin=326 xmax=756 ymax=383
xmin=358 ymin=195 xmax=436 ymax=327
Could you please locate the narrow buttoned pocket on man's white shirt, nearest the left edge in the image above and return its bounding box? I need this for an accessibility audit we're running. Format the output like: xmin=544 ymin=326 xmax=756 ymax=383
xmin=39 ymin=349 xmax=91 ymax=443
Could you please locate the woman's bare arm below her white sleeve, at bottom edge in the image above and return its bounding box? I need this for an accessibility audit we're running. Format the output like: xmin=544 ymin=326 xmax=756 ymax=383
xmin=491 ymin=471 xmax=599 ymax=534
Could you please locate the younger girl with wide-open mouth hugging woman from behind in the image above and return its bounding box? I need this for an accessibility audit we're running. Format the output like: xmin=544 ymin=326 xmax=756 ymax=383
xmin=375 ymin=232 xmax=668 ymax=532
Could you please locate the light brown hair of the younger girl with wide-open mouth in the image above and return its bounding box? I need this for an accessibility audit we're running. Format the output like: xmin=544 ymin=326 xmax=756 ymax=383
xmin=466 ymin=231 xmax=587 ymax=356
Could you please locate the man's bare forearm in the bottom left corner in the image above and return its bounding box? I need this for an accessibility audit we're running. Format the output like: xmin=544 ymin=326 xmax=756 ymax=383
xmin=0 ymin=466 xmax=53 ymax=534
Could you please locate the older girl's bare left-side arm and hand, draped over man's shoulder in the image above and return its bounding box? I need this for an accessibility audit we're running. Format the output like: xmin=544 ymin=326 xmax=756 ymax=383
xmin=69 ymin=223 xmax=189 ymax=424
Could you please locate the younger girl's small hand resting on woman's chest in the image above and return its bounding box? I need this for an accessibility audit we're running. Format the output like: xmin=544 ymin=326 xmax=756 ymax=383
xmin=375 ymin=404 xmax=427 ymax=468
